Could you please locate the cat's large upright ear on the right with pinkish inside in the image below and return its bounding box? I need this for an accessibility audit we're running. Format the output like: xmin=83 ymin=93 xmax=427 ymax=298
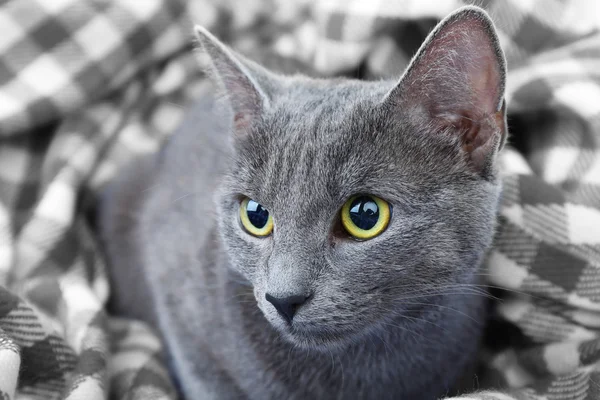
xmin=385 ymin=7 xmax=507 ymax=172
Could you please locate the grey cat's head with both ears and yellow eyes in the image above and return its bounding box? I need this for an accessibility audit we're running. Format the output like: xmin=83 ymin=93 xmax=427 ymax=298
xmin=197 ymin=7 xmax=506 ymax=348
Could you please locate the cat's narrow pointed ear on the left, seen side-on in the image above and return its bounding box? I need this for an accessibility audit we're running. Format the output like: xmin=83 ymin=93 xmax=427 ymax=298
xmin=194 ymin=25 xmax=269 ymax=135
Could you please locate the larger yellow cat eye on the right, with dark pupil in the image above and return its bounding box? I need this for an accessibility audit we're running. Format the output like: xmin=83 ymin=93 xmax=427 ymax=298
xmin=341 ymin=195 xmax=391 ymax=240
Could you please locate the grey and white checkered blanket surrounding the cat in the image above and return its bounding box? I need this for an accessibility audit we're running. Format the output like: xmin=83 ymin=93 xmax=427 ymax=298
xmin=0 ymin=0 xmax=600 ymax=400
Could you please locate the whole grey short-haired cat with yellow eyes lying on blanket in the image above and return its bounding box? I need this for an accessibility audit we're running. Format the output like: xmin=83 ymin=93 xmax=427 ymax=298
xmin=100 ymin=7 xmax=507 ymax=400
